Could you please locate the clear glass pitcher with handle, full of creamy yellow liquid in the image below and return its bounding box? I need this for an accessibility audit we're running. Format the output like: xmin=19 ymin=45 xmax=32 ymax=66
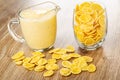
xmin=8 ymin=2 xmax=60 ymax=51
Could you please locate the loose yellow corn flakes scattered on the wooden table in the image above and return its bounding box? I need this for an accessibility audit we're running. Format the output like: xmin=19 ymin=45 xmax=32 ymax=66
xmin=11 ymin=46 xmax=96 ymax=77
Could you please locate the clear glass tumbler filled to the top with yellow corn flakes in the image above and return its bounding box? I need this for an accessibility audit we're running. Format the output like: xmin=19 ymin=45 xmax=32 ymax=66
xmin=73 ymin=1 xmax=107 ymax=50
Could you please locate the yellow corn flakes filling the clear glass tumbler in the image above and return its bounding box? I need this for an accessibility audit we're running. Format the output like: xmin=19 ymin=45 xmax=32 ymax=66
xmin=74 ymin=2 xmax=106 ymax=46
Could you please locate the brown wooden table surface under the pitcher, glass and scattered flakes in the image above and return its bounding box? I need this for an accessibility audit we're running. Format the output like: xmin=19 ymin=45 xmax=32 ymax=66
xmin=0 ymin=0 xmax=120 ymax=80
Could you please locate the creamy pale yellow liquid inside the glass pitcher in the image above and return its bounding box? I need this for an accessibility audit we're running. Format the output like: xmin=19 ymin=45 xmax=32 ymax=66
xmin=20 ymin=9 xmax=56 ymax=49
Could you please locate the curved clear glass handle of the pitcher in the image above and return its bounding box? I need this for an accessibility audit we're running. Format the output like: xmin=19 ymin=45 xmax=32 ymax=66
xmin=7 ymin=18 xmax=25 ymax=43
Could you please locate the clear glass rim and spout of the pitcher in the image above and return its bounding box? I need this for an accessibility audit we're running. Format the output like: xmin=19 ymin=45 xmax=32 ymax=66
xmin=17 ymin=1 xmax=61 ymax=20
